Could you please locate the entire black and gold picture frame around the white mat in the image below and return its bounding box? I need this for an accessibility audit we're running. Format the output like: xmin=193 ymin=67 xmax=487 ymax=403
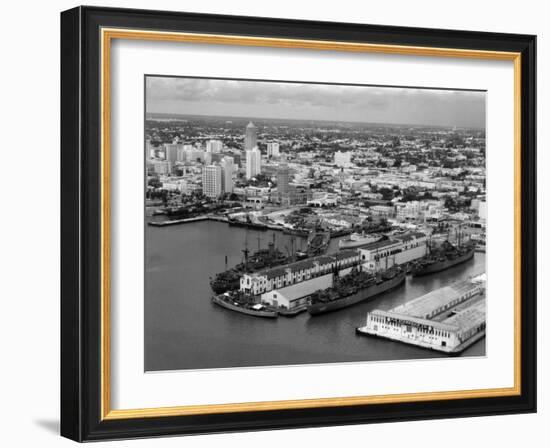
xmin=61 ymin=7 xmax=537 ymax=442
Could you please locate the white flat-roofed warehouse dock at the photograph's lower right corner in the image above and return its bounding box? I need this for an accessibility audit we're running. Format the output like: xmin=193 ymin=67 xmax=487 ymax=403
xmin=356 ymin=274 xmax=486 ymax=355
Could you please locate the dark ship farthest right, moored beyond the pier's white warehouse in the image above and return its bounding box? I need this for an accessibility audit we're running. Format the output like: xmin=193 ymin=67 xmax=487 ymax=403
xmin=411 ymin=241 xmax=475 ymax=277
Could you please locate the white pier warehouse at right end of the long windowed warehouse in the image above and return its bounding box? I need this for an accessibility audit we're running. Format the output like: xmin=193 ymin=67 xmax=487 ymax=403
xmin=358 ymin=232 xmax=428 ymax=271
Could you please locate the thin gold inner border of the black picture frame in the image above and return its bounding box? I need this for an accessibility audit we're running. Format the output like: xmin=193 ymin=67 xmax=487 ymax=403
xmin=100 ymin=28 xmax=521 ymax=420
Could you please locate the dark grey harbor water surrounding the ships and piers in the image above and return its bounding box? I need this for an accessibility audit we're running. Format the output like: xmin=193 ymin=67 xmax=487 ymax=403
xmin=145 ymin=221 xmax=490 ymax=371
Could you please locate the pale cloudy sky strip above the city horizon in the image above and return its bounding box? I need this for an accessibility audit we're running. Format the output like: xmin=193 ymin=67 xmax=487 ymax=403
xmin=146 ymin=77 xmax=486 ymax=128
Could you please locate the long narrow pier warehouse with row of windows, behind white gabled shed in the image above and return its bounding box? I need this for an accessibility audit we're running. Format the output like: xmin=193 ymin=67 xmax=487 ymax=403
xmin=240 ymin=250 xmax=361 ymax=296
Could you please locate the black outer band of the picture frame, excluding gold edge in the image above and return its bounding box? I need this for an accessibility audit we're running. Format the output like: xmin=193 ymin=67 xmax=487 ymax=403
xmin=61 ymin=7 xmax=537 ymax=441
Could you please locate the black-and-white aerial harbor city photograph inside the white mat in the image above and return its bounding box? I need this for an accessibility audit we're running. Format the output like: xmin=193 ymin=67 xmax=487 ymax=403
xmin=144 ymin=75 xmax=487 ymax=371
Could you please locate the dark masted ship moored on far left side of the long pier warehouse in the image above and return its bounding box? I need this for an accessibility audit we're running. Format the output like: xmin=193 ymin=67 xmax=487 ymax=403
xmin=210 ymin=235 xmax=291 ymax=294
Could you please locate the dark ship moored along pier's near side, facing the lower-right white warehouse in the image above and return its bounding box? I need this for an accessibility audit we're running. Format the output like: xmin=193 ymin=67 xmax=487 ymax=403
xmin=307 ymin=267 xmax=406 ymax=316
